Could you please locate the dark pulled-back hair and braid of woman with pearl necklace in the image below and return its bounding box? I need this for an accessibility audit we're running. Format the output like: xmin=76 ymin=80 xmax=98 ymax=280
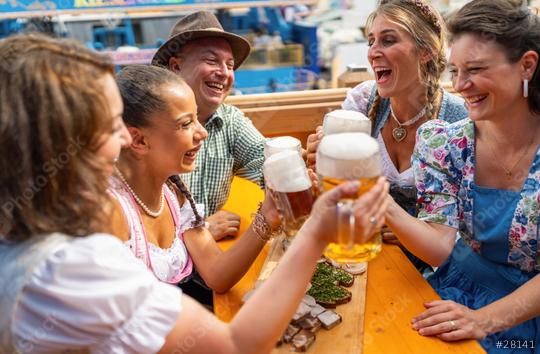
xmin=116 ymin=65 xmax=204 ymax=227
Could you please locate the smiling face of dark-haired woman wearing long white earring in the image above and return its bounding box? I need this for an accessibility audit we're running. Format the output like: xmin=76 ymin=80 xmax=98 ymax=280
xmin=449 ymin=34 xmax=526 ymax=120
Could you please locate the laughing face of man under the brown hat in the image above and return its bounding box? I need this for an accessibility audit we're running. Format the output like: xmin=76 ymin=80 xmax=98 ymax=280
xmin=170 ymin=38 xmax=234 ymax=121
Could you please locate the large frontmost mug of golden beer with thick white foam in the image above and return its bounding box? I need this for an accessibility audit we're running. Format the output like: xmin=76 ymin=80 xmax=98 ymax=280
xmin=317 ymin=133 xmax=382 ymax=263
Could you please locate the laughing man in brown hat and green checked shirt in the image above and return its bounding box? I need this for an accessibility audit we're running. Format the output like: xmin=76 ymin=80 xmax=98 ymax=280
xmin=152 ymin=11 xmax=264 ymax=239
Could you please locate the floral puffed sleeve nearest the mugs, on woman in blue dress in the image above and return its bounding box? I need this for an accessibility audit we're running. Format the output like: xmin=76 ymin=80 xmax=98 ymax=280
xmin=412 ymin=120 xmax=460 ymax=229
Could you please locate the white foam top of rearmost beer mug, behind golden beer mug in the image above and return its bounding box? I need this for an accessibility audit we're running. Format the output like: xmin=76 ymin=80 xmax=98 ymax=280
xmin=323 ymin=109 xmax=371 ymax=135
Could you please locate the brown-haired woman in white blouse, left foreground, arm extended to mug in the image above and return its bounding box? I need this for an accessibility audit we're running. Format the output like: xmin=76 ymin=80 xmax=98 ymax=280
xmin=0 ymin=35 xmax=387 ymax=353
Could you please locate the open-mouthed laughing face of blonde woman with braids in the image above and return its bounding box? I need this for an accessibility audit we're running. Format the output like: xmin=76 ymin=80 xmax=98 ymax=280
xmin=368 ymin=15 xmax=426 ymax=98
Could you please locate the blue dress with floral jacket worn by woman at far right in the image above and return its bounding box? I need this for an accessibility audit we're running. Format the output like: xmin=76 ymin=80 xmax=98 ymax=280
xmin=413 ymin=119 xmax=540 ymax=354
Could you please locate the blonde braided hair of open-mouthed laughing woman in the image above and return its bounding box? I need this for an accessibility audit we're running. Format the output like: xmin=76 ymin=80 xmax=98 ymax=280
xmin=366 ymin=0 xmax=446 ymax=120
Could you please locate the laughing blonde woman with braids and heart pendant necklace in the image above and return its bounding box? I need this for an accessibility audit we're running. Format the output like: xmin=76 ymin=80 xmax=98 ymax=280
xmin=307 ymin=0 xmax=468 ymax=270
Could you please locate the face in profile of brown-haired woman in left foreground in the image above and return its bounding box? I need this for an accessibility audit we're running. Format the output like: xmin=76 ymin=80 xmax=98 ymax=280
xmin=97 ymin=74 xmax=131 ymax=175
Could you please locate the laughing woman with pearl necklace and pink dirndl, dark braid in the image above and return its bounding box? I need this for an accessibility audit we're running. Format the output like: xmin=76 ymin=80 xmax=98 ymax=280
xmin=107 ymin=65 xmax=279 ymax=292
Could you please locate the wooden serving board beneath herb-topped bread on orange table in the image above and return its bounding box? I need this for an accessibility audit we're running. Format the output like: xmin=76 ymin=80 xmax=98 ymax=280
xmin=259 ymin=237 xmax=367 ymax=354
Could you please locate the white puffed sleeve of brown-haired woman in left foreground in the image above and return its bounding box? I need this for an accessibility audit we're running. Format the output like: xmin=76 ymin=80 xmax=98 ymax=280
xmin=12 ymin=234 xmax=181 ymax=353
